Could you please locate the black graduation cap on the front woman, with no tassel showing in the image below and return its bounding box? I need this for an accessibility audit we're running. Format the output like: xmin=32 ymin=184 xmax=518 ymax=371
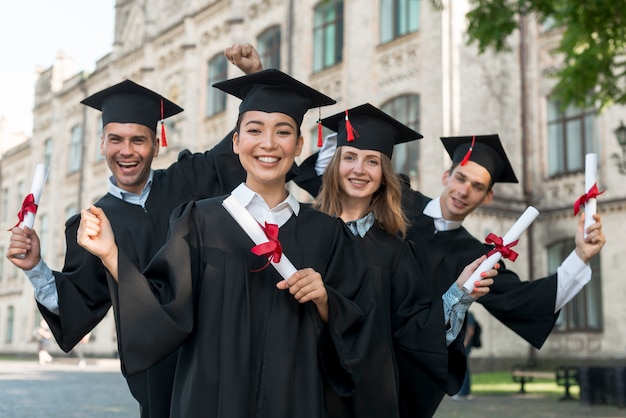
xmin=213 ymin=68 xmax=337 ymax=126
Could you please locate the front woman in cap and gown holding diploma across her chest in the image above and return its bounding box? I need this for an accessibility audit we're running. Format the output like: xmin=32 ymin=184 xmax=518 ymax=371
xmin=78 ymin=70 xmax=374 ymax=418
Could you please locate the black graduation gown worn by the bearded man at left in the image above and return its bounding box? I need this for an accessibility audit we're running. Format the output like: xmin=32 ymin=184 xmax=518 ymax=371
xmin=39 ymin=133 xmax=245 ymax=418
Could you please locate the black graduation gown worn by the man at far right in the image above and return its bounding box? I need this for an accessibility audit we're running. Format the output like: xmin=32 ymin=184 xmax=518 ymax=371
xmin=394 ymin=185 xmax=558 ymax=417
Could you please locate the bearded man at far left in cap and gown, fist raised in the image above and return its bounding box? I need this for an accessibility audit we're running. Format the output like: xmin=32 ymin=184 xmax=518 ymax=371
xmin=7 ymin=45 xmax=260 ymax=418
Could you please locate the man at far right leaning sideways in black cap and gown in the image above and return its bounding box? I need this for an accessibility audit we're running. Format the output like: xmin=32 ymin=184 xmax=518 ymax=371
xmin=394 ymin=135 xmax=605 ymax=417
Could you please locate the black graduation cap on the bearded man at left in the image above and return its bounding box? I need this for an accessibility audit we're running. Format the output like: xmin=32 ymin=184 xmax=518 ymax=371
xmin=81 ymin=80 xmax=183 ymax=133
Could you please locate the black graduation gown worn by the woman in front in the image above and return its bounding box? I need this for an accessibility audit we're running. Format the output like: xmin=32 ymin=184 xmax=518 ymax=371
xmin=115 ymin=197 xmax=374 ymax=418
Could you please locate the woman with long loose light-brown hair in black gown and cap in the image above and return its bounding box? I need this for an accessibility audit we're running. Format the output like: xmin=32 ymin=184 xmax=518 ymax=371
xmin=304 ymin=103 xmax=496 ymax=418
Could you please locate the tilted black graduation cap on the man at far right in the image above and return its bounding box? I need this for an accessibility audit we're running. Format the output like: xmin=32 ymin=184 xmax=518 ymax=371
xmin=441 ymin=134 xmax=518 ymax=183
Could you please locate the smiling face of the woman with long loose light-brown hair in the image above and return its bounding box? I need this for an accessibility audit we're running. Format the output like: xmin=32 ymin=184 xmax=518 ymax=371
xmin=339 ymin=145 xmax=383 ymax=207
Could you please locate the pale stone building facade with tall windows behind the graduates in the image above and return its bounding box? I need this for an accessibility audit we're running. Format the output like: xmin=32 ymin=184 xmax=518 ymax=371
xmin=0 ymin=0 xmax=626 ymax=362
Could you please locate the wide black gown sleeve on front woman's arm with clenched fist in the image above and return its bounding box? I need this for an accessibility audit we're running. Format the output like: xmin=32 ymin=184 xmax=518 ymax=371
xmin=110 ymin=202 xmax=197 ymax=376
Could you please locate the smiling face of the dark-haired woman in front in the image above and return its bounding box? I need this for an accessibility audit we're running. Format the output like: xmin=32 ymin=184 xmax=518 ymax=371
xmin=233 ymin=110 xmax=304 ymax=194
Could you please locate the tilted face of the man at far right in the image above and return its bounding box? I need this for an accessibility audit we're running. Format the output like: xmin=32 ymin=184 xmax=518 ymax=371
xmin=441 ymin=161 xmax=493 ymax=221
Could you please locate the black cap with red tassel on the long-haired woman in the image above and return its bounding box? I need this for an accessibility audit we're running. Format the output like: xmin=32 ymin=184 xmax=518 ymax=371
xmin=322 ymin=103 xmax=423 ymax=158
